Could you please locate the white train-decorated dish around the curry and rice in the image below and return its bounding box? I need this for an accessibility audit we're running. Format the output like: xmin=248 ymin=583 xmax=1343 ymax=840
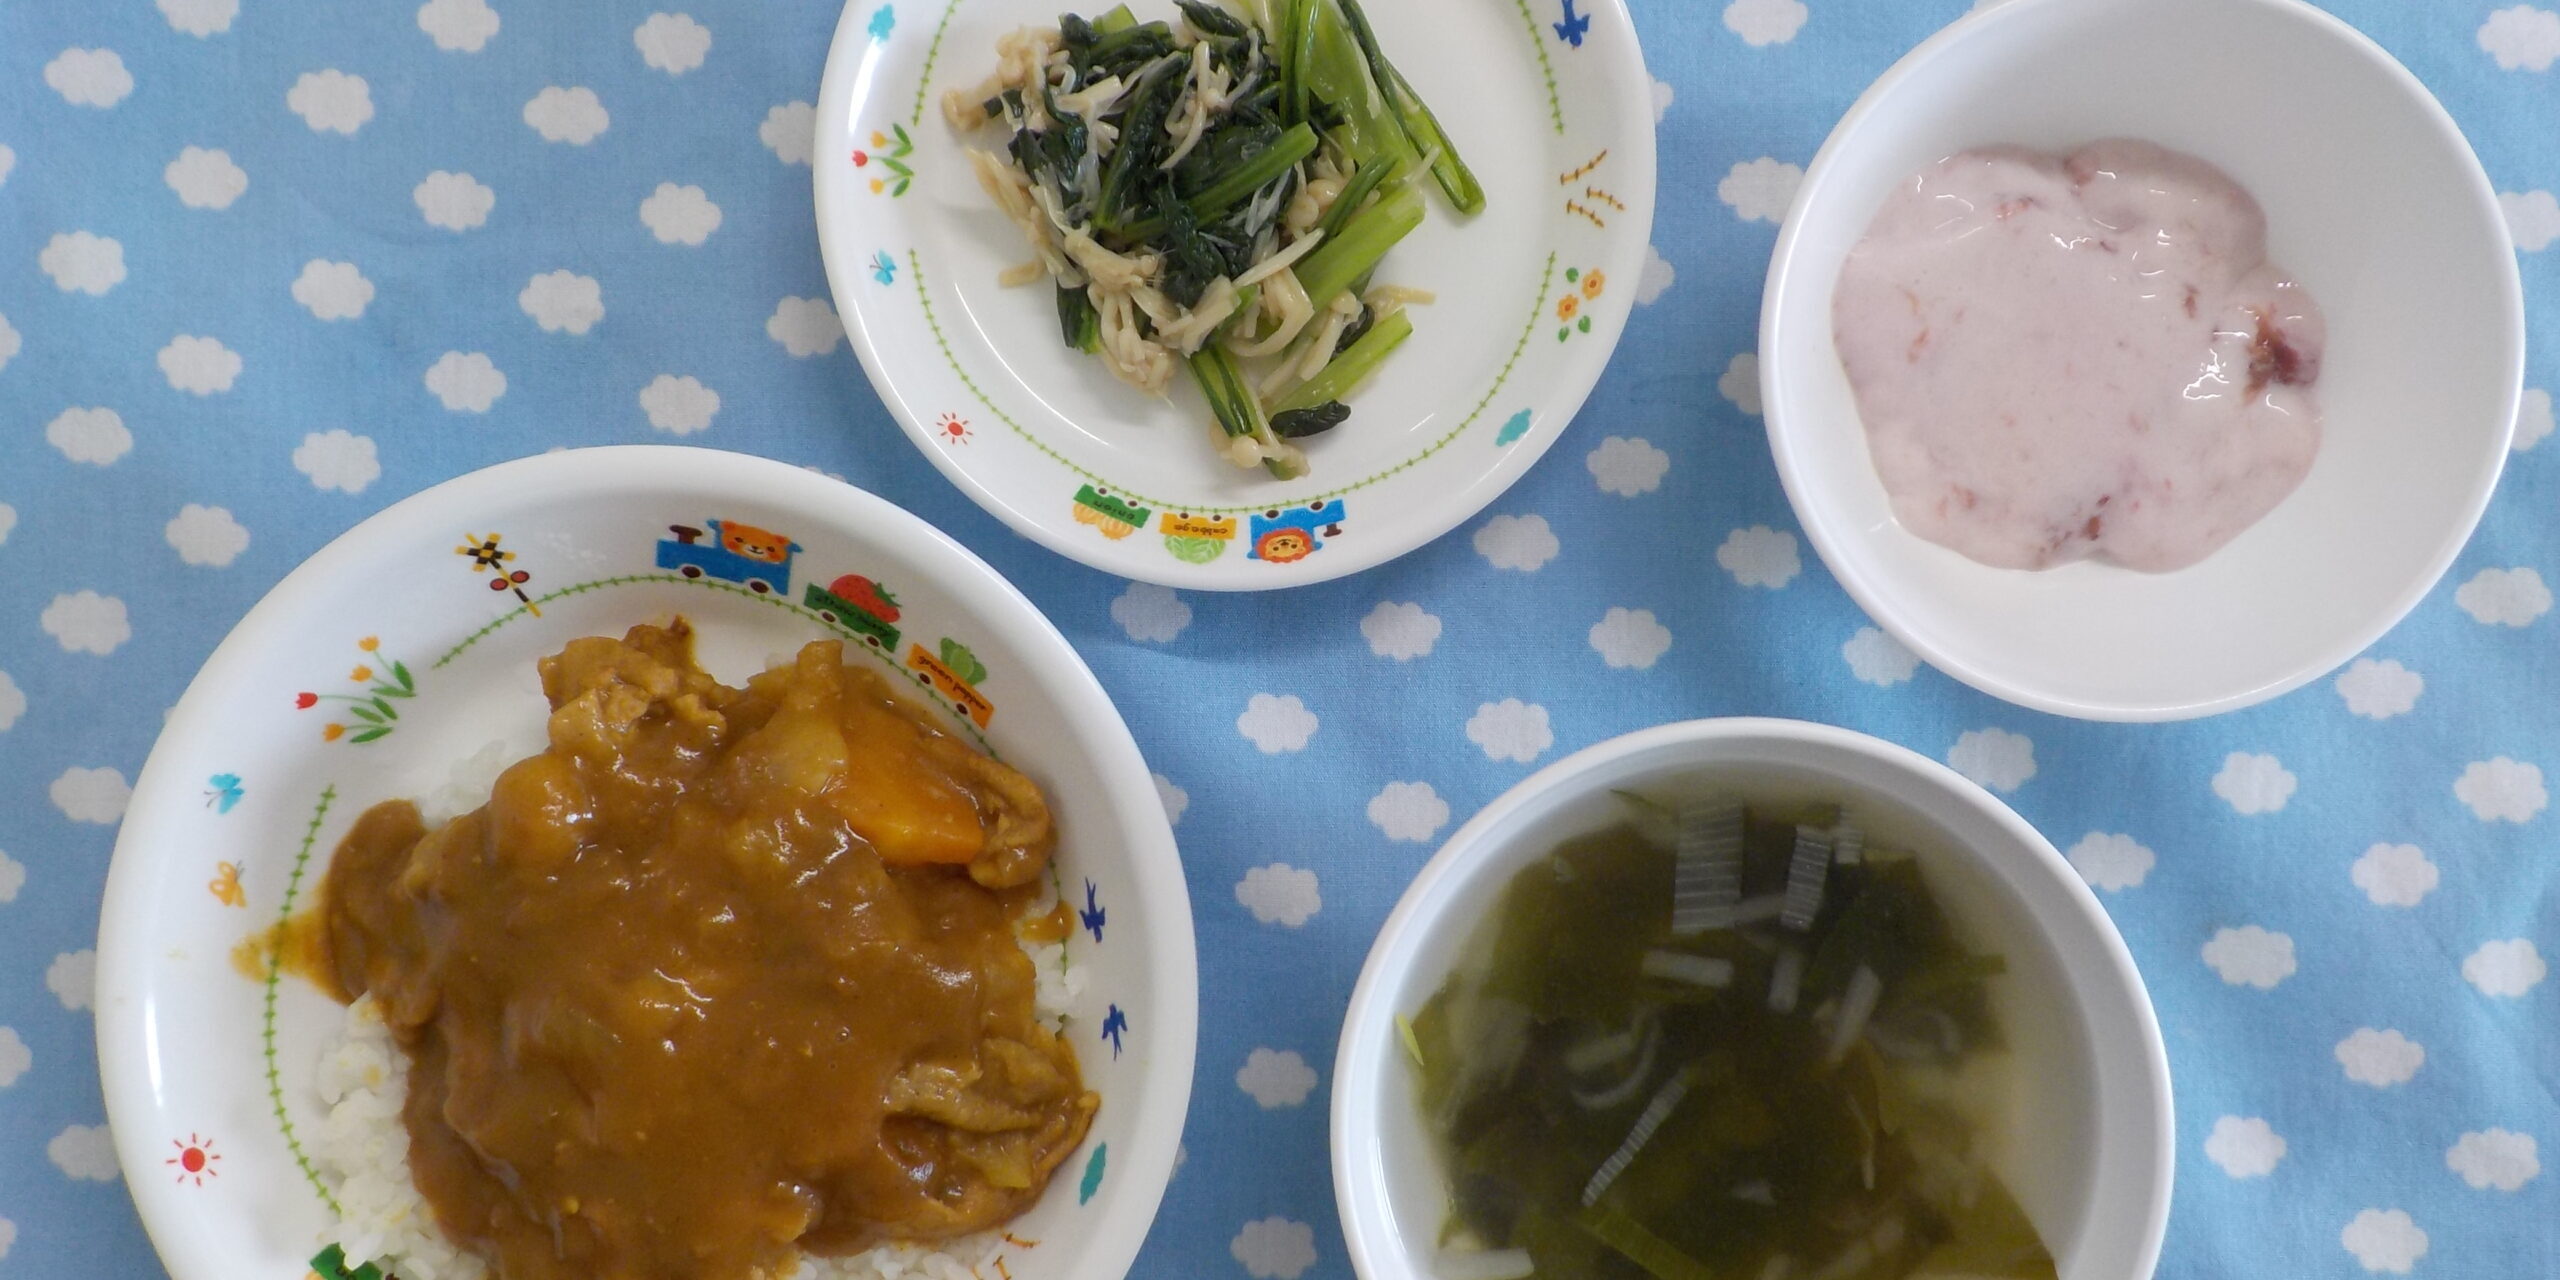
xmin=97 ymin=448 xmax=1198 ymax=1280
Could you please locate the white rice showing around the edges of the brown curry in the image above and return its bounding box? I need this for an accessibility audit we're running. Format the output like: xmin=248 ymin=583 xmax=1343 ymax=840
xmin=310 ymin=742 xmax=1085 ymax=1280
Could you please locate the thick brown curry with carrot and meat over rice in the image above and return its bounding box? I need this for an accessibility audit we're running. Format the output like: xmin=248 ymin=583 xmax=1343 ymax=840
xmin=323 ymin=620 xmax=1096 ymax=1280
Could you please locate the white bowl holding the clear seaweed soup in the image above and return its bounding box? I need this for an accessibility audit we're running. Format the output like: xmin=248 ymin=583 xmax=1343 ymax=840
xmin=1334 ymin=719 xmax=2176 ymax=1280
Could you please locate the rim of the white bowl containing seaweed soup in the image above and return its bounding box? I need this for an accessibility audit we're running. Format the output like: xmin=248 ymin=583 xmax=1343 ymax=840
xmin=1331 ymin=717 xmax=2179 ymax=1280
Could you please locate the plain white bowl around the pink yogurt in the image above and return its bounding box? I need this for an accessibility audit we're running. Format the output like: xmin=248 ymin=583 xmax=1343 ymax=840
xmin=1759 ymin=0 xmax=2524 ymax=719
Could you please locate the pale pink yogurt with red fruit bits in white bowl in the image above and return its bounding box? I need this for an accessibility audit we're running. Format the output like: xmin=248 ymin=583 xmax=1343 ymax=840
xmin=1830 ymin=138 xmax=2327 ymax=571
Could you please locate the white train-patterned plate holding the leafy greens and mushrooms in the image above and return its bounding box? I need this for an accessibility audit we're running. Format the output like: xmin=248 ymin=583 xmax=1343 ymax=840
xmin=812 ymin=0 xmax=1654 ymax=591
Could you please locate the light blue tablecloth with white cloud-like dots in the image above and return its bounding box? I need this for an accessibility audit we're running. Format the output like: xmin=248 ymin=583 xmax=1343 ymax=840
xmin=0 ymin=0 xmax=2560 ymax=1280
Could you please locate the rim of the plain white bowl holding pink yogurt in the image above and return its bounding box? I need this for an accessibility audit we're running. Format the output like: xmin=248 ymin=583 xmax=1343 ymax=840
xmin=1756 ymin=0 xmax=2524 ymax=722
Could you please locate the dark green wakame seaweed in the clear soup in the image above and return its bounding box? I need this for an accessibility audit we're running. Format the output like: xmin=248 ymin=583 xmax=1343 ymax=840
xmin=1403 ymin=801 xmax=2056 ymax=1280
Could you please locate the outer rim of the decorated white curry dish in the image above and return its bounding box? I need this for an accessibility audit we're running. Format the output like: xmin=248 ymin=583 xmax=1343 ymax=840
xmin=92 ymin=445 xmax=1198 ymax=1280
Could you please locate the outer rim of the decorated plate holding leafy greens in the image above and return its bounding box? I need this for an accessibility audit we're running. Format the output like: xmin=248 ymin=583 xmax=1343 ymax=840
xmin=809 ymin=0 xmax=1659 ymax=591
